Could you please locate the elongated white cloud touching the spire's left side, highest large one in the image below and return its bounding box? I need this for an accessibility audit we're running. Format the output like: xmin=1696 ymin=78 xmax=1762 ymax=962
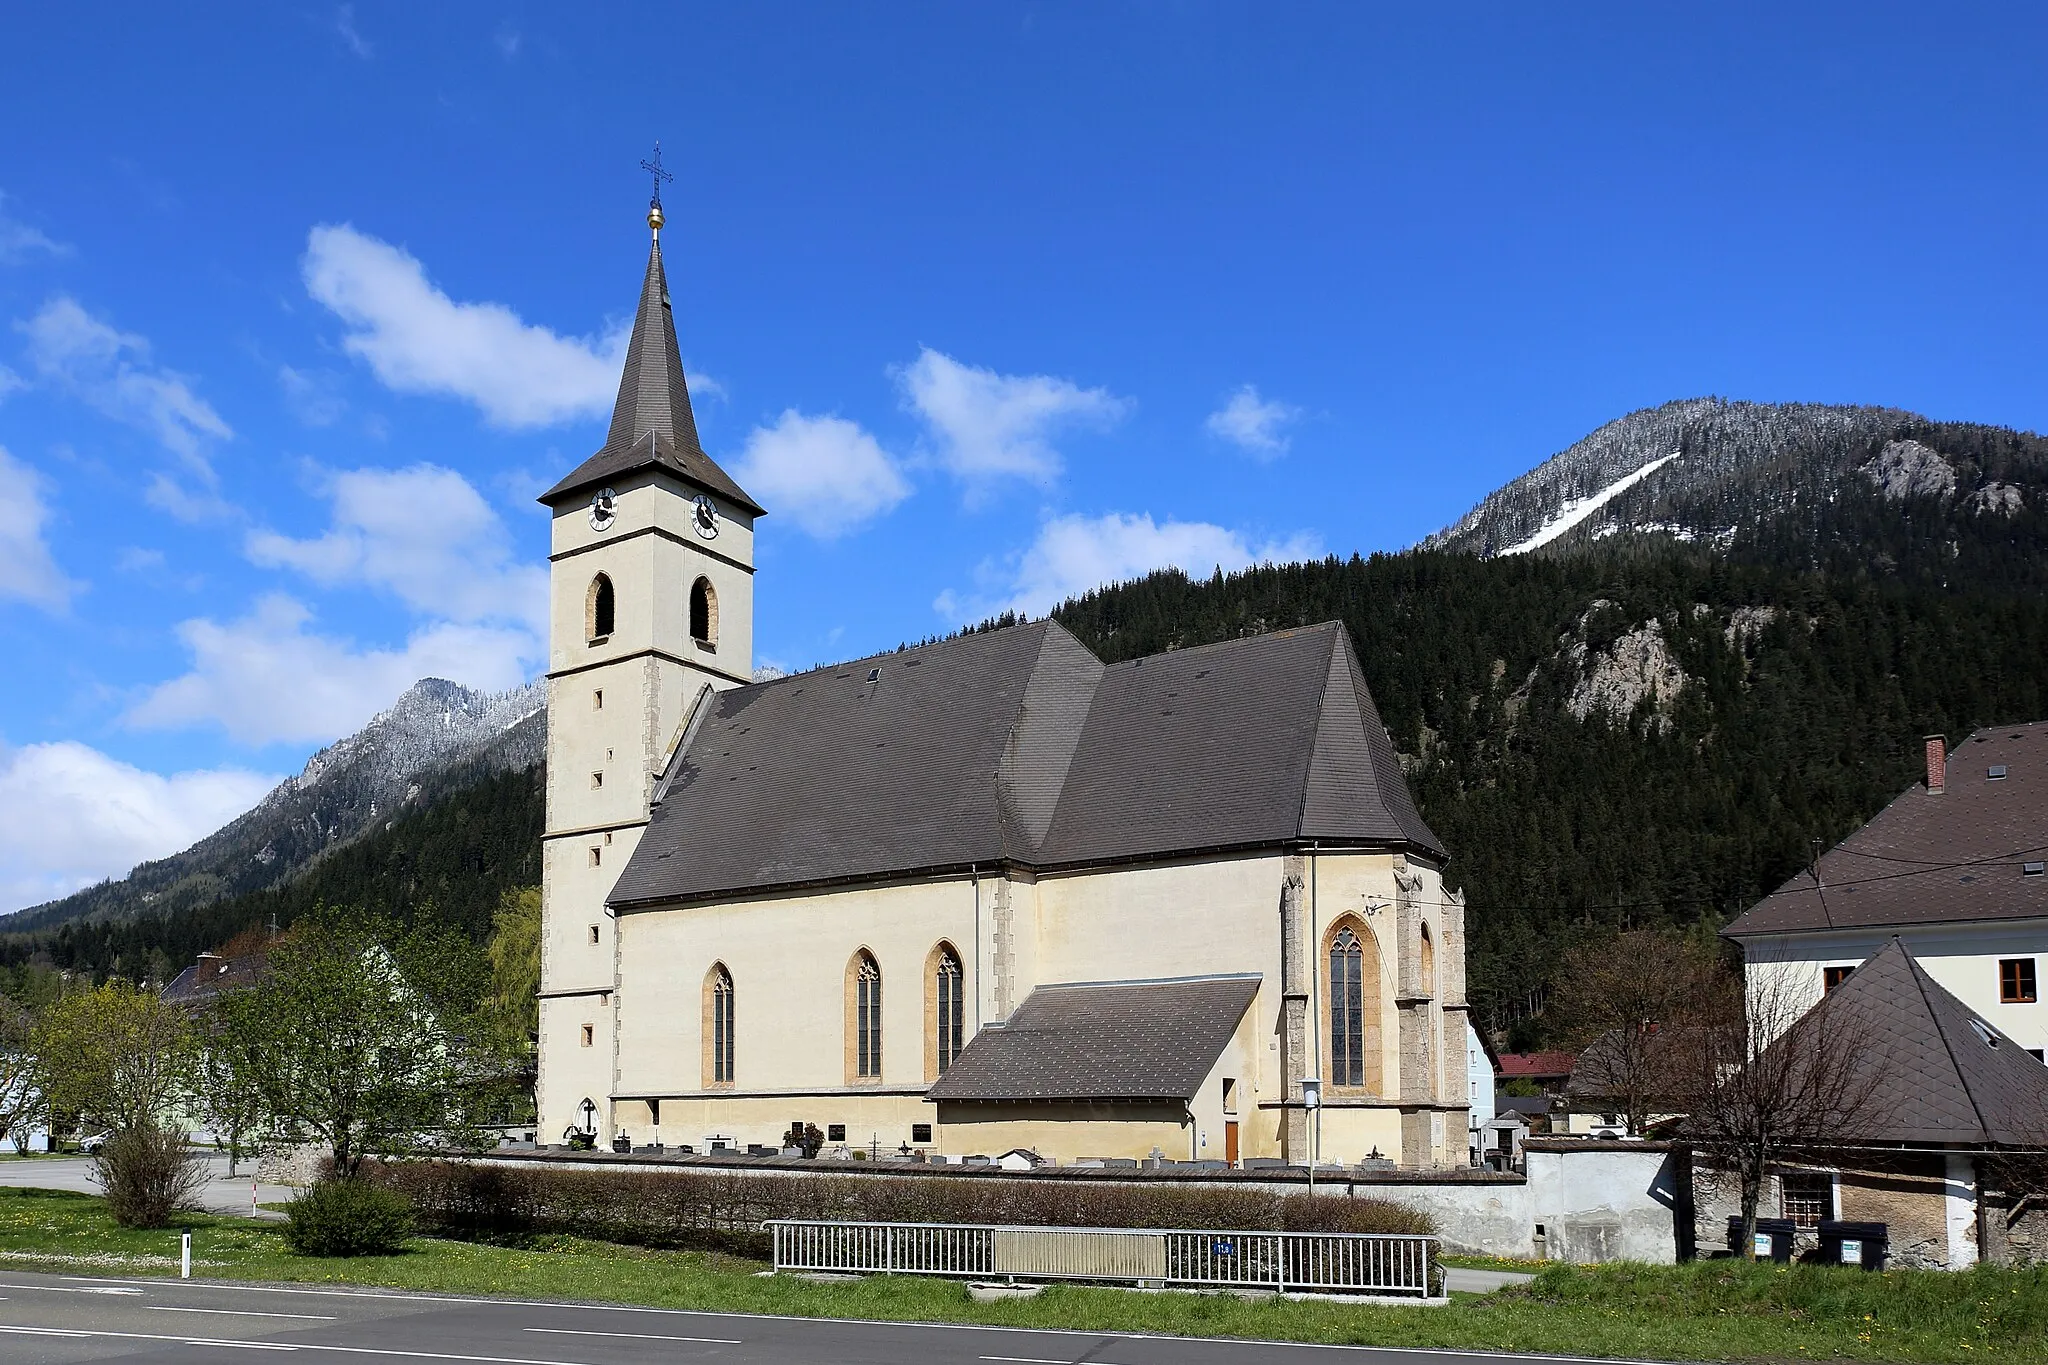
xmin=299 ymin=223 xmax=627 ymax=428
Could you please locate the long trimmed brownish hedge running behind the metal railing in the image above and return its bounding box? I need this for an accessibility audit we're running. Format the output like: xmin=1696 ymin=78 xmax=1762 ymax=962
xmin=362 ymin=1160 xmax=1434 ymax=1257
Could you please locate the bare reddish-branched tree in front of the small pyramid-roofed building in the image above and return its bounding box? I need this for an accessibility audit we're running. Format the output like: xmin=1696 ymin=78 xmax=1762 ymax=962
xmin=1669 ymin=974 xmax=1888 ymax=1257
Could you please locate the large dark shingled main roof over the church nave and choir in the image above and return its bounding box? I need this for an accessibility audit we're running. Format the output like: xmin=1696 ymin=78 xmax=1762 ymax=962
xmin=610 ymin=622 xmax=1444 ymax=907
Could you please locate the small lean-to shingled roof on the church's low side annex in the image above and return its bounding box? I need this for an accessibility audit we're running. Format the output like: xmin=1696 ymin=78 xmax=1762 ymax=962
xmin=926 ymin=974 xmax=1260 ymax=1101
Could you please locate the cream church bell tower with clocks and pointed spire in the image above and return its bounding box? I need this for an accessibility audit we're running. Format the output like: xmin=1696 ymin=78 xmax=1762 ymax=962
xmin=537 ymin=179 xmax=762 ymax=1144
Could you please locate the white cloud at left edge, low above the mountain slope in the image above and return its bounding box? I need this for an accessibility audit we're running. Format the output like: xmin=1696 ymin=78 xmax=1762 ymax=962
xmin=0 ymin=741 xmax=279 ymax=909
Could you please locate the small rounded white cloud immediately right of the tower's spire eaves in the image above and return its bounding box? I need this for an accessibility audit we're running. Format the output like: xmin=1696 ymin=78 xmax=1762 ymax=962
xmin=733 ymin=409 xmax=909 ymax=540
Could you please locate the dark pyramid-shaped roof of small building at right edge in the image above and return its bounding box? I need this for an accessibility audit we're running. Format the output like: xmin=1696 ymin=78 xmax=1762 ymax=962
xmin=1808 ymin=939 xmax=2048 ymax=1146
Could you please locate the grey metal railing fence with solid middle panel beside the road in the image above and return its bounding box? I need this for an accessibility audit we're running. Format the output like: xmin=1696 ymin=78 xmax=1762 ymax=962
xmin=762 ymin=1218 xmax=1436 ymax=1297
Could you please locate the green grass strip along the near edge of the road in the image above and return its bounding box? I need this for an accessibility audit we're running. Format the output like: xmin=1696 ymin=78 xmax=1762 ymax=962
xmin=0 ymin=1189 xmax=2048 ymax=1361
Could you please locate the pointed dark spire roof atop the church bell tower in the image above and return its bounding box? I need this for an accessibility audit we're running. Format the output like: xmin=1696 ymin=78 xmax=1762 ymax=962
xmin=541 ymin=239 xmax=762 ymax=516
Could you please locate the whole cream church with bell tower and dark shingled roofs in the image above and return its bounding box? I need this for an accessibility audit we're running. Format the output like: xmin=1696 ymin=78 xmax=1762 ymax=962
xmin=539 ymin=203 xmax=1466 ymax=1166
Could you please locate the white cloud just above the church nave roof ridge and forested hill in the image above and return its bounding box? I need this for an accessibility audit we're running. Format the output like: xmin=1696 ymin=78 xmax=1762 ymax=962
xmin=932 ymin=512 xmax=1321 ymax=622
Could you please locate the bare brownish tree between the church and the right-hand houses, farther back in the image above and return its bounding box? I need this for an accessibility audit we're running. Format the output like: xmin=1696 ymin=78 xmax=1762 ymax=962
xmin=1546 ymin=929 xmax=1726 ymax=1136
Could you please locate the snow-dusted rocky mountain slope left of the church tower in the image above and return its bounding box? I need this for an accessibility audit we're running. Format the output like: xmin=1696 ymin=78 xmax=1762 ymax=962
xmin=0 ymin=677 xmax=547 ymax=933
